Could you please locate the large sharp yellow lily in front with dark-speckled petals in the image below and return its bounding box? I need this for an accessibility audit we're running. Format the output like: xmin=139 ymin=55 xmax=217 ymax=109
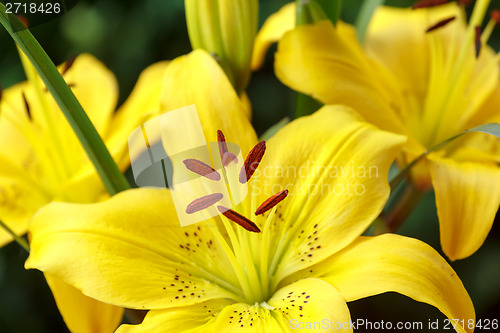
xmin=26 ymin=50 xmax=474 ymax=333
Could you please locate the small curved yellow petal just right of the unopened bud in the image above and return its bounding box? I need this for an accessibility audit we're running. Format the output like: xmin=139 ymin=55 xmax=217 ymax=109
xmin=252 ymin=2 xmax=296 ymax=71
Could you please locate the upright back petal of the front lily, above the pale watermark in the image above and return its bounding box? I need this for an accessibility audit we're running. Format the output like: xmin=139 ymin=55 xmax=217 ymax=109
xmin=161 ymin=50 xmax=257 ymax=156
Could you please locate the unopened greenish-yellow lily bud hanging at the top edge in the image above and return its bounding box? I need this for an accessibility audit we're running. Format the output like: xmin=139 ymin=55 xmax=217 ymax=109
xmin=185 ymin=0 xmax=258 ymax=92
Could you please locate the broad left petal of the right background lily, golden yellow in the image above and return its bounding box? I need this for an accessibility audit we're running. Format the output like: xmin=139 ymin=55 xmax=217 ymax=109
xmin=275 ymin=21 xmax=405 ymax=140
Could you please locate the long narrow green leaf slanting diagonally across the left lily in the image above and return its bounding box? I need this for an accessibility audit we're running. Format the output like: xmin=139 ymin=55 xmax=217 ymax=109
xmin=0 ymin=3 xmax=130 ymax=195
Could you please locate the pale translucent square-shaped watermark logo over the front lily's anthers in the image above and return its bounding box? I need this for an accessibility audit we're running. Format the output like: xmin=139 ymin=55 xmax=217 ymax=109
xmin=129 ymin=105 xmax=254 ymax=227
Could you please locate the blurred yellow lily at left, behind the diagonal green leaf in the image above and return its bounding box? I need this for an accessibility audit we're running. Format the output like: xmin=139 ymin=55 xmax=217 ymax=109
xmin=0 ymin=54 xmax=165 ymax=333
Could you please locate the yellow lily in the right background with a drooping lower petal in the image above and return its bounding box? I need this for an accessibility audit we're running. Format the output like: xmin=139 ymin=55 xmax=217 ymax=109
xmin=270 ymin=0 xmax=500 ymax=260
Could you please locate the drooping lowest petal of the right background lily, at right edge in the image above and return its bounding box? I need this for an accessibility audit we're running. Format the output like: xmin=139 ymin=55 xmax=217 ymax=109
xmin=429 ymin=156 xmax=500 ymax=260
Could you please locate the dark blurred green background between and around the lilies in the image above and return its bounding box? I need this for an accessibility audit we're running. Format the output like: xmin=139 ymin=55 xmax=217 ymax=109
xmin=0 ymin=0 xmax=500 ymax=333
